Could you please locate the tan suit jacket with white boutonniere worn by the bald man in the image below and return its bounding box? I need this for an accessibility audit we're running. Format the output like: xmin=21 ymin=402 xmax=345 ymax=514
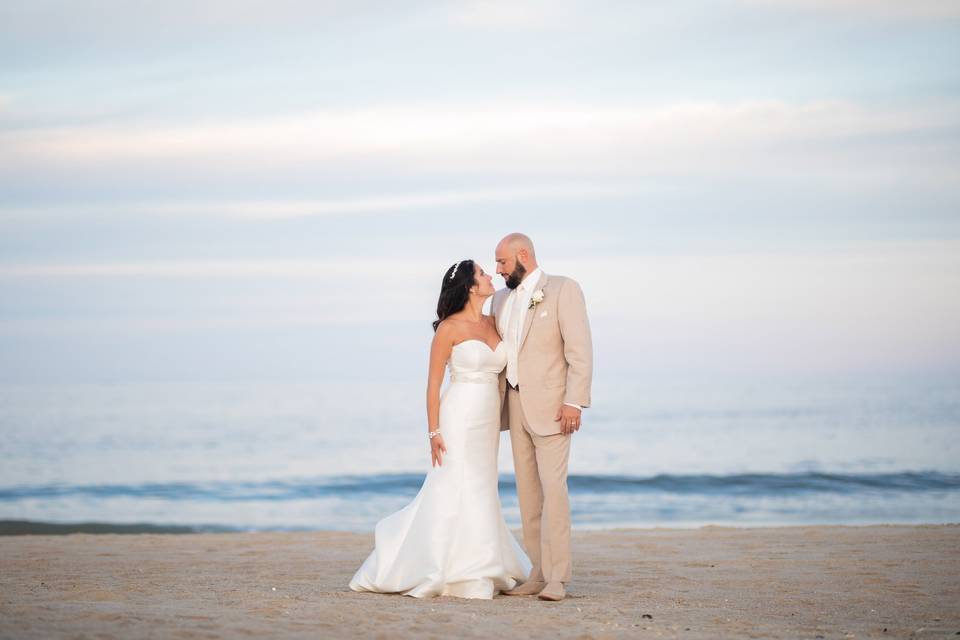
xmin=491 ymin=273 xmax=593 ymax=436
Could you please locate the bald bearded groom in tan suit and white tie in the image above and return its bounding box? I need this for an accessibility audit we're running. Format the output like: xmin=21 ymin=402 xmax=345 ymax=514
xmin=492 ymin=233 xmax=593 ymax=601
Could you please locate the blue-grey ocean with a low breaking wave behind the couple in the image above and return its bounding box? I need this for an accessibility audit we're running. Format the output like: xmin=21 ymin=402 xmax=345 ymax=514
xmin=0 ymin=375 xmax=960 ymax=532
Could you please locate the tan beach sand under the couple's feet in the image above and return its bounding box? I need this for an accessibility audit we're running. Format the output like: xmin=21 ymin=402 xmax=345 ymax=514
xmin=0 ymin=525 xmax=960 ymax=638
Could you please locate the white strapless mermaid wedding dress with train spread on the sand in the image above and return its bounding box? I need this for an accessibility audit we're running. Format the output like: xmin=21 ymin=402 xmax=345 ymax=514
xmin=350 ymin=340 xmax=530 ymax=599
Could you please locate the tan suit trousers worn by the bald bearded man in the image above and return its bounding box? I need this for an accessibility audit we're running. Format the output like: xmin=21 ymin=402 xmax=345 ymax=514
xmin=507 ymin=387 xmax=571 ymax=582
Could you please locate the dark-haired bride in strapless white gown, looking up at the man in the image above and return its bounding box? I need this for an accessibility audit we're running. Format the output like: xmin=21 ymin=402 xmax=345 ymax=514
xmin=350 ymin=260 xmax=531 ymax=599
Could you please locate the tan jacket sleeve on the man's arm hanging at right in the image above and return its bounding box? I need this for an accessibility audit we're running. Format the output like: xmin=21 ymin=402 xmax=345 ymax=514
xmin=557 ymin=279 xmax=593 ymax=407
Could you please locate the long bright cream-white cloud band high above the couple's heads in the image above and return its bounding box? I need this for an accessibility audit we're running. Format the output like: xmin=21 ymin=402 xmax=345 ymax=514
xmin=0 ymin=101 xmax=960 ymax=184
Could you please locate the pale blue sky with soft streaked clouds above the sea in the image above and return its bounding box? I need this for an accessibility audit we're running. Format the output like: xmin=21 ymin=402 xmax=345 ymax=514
xmin=0 ymin=0 xmax=960 ymax=383
